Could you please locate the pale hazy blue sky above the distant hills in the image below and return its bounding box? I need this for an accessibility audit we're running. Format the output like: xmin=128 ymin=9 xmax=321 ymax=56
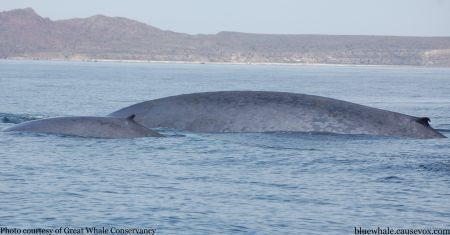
xmin=0 ymin=0 xmax=450 ymax=36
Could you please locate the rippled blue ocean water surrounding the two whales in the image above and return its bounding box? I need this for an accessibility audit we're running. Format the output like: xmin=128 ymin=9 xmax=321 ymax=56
xmin=0 ymin=60 xmax=450 ymax=234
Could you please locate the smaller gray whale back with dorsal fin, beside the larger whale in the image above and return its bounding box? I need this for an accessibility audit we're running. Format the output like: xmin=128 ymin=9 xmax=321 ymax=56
xmin=4 ymin=115 xmax=161 ymax=139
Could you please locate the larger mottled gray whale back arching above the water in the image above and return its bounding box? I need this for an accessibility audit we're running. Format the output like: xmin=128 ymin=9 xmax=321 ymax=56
xmin=109 ymin=91 xmax=444 ymax=138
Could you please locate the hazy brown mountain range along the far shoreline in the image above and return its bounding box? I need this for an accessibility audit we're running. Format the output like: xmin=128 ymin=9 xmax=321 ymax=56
xmin=0 ymin=8 xmax=450 ymax=67
